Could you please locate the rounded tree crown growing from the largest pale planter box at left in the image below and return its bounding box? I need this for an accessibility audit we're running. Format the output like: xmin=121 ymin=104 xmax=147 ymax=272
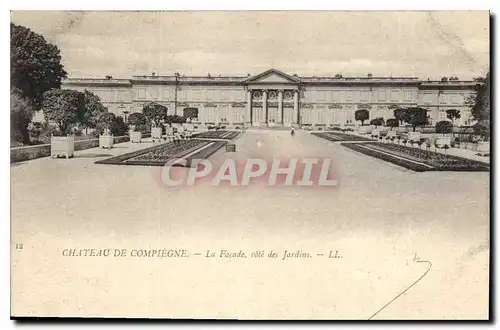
xmin=42 ymin=89 xmax=85 ymax=134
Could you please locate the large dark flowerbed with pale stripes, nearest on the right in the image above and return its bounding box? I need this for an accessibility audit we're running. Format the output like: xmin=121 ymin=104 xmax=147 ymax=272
xmin=341 ymin=142 xmax=490 ymax=172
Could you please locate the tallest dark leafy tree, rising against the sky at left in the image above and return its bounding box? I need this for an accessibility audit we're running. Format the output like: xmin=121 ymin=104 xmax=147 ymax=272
xmin=10 ymin=23 xmax=66 ymax=110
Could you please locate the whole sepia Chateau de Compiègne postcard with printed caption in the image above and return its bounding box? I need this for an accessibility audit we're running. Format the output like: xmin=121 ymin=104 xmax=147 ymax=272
xmin=10 ymin=11 xmax=491 ymax=320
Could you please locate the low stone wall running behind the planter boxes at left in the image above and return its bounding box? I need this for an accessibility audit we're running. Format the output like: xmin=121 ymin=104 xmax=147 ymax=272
xmin=10 ymin=136 xmax=129 ymax=163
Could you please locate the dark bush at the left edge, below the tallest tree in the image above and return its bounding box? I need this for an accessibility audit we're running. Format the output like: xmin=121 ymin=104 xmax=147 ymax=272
xmin=10 ymin=89 xmax=34 ymax=144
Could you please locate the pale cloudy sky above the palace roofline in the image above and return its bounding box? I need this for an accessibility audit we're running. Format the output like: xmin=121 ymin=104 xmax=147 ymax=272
xmin=11 ymin=11 xmax=490 ymax=79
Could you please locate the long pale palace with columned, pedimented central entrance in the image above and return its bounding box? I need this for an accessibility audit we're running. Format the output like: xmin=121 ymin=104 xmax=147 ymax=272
xmin=62 ymin=69 xmax=475 ymax=126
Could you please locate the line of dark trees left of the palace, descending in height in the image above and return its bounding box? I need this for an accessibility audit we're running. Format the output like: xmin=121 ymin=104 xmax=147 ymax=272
xmin=10 ymin=23 xmax=191 ymax=144
